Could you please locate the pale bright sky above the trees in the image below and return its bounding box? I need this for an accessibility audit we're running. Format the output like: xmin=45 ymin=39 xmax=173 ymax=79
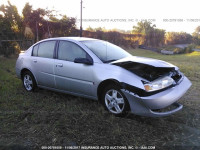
xmin=0 ymin=0 xmax=200 ymax=33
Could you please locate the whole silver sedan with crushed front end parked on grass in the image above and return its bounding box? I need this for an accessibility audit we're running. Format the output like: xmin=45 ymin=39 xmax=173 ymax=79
xmin=16 ymin=37 xmax=191 ymax=117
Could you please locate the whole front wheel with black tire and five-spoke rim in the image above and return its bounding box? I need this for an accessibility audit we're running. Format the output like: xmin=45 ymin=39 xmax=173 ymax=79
xmin=101 ymin=84 xmax=130 ymax=116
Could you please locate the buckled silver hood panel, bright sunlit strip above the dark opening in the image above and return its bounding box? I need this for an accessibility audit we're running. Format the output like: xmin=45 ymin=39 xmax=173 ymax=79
xmin=111 ymin=56 xmax=176 ymax=68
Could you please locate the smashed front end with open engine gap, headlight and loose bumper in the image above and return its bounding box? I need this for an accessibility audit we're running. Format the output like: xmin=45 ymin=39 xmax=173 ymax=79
xmin=113 ymin=61 xmax=191 ymax=117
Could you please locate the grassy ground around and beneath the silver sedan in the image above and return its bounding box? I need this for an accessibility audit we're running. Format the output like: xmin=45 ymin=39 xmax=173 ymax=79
xmin=0 ymin=49 xmax=200 ymax=149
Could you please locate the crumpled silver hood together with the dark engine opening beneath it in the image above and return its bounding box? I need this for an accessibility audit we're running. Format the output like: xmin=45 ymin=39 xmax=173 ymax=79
xmin=111 ymin=56 xmax=179 ymax=81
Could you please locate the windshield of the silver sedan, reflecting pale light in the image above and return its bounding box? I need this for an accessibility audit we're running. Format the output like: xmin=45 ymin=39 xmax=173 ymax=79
xmin=81 ymin=40 xmax=131 ymax=63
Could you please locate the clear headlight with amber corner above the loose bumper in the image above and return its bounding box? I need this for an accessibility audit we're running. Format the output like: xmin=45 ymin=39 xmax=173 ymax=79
xmin=144 ymin=76 xmax=174 ymax=92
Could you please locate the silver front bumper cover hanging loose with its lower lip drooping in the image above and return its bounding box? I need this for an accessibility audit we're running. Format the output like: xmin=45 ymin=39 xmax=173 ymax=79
xmin=122 ymin=76 xmax=192 ymax=117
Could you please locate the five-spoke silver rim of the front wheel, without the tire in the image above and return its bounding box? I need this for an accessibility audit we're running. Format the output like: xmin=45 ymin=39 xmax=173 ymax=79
xmin=105 ymin=89 xmax=125 ymax=114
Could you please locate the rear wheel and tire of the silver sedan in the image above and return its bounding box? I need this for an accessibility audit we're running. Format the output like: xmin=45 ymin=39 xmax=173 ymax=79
xmin=22 ymin=71 xmax=37 ymax=92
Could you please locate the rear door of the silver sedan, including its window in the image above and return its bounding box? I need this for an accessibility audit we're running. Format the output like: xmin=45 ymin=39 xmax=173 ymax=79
xmin=32 ymin=40 xmax=56 ymax=88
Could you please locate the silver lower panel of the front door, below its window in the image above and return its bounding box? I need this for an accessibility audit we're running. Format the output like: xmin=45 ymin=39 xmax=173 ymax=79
xmin=54 ymin=60 xmax=94 ymax=96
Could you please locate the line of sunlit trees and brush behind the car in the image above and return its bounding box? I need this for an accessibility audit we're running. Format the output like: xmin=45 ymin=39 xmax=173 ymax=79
xmin=0 ymin=1 xmax=200 ymax=55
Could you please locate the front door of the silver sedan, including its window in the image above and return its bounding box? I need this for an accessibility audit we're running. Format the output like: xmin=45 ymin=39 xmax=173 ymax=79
xmin=54 ymin=41 xmax=94 ymax=96
